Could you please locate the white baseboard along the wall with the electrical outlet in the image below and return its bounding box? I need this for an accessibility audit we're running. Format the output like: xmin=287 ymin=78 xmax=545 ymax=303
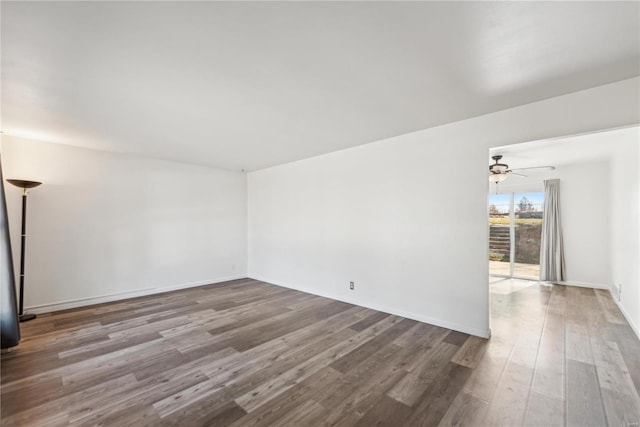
xmin=249 ymin=275 xmax=491 ymax=338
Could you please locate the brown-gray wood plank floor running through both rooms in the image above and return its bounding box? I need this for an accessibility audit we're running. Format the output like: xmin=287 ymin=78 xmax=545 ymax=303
xmin=1 ymin=279 xmax=640 ymax=427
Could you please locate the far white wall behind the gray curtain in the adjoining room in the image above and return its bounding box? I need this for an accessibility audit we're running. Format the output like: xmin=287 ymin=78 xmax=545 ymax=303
xmin=491 ymin=159 xmax=611 ymax=288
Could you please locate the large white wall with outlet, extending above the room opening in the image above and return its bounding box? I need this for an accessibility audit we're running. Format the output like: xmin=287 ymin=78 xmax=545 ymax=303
xmin=248 ymin=78 xmax=640 ymax=336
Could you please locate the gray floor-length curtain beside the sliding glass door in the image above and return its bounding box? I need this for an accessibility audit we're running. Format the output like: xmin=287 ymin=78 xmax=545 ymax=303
xmin=540 ymin=179 xmax=565 ymax=282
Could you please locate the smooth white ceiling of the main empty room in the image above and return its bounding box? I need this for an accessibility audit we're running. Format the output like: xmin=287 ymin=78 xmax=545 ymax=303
xmin=1 ymin=1 xmax=640 ymax=170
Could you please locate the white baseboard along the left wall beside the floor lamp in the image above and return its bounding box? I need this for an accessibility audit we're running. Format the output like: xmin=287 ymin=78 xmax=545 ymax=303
xmin=25 ymin=274 xmax=247 ymax=314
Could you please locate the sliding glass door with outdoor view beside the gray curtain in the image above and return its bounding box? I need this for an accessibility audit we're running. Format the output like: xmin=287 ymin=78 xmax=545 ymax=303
xmin=489 ymin=193 xmax=544 ymax=279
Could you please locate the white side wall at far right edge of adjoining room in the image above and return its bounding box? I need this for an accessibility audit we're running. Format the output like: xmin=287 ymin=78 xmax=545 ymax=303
xmin=610 ymin=135 xmax=640 ymax=336
